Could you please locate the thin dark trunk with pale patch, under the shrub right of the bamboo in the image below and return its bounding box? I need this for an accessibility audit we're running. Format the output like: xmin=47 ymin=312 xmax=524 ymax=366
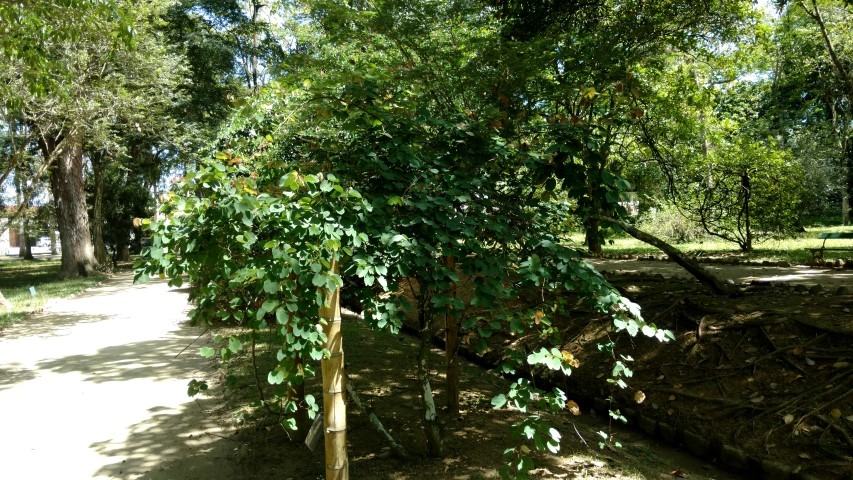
xmin=417 ymin=291 xmax=444 ymax=458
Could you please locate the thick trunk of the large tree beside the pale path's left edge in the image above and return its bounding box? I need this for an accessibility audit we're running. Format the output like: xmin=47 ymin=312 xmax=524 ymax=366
xmin=47 ymin=134 xmax=97 ymax=279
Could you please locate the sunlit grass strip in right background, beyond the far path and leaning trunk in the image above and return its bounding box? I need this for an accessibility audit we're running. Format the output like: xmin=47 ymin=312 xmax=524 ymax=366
xmin=570 ymin=226 xmax=853 ymax=264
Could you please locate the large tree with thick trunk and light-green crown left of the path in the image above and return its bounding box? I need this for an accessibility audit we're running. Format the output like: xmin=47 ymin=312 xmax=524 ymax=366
xmin=3 ymin=1 xmax=188 ymax=277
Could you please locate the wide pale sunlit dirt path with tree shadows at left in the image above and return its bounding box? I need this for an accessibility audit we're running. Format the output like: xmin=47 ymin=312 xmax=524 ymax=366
xmin=0 ymin=274 xmax=235 ymax=480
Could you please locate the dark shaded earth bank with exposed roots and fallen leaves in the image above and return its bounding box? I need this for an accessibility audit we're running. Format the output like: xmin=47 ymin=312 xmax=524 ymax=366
xmin=540 ymin=260 xmax=853 ymax=479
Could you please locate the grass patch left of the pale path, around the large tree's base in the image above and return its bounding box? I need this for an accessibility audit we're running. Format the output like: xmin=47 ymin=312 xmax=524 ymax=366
xmin=0 ymin=257 xmax=107 ymax=329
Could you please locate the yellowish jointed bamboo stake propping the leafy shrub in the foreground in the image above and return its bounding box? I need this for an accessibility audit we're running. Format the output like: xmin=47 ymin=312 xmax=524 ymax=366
xmin=320 ymin=260 xmax=349 ymax=480
